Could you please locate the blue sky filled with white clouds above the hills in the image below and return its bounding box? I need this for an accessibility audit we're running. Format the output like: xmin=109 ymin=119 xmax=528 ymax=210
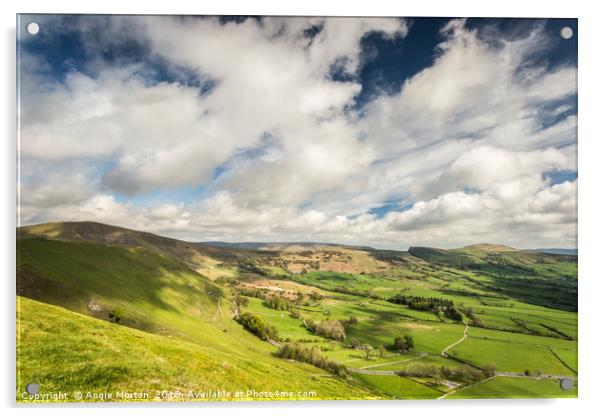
xmin=17 ymin=15 xmax=577 ymax=250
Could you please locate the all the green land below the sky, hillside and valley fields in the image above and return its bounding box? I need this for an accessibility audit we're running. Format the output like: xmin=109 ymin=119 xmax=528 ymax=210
xmin=17 ymin=223 xmax=578 ymax=400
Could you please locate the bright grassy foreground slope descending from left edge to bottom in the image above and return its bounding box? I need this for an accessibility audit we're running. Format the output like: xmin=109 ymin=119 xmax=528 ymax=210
xmin=17 ymin=297 xmax=370 ymax=399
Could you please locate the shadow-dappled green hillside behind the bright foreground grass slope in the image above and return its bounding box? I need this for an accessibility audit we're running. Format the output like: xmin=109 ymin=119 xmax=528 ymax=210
xmin=18 ymin=239 xmax=370 ymax=397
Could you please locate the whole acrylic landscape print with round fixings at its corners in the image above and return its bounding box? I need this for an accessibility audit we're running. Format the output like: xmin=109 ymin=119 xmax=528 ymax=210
xmin=16 ymin=14 xmax=578 ymax=403
